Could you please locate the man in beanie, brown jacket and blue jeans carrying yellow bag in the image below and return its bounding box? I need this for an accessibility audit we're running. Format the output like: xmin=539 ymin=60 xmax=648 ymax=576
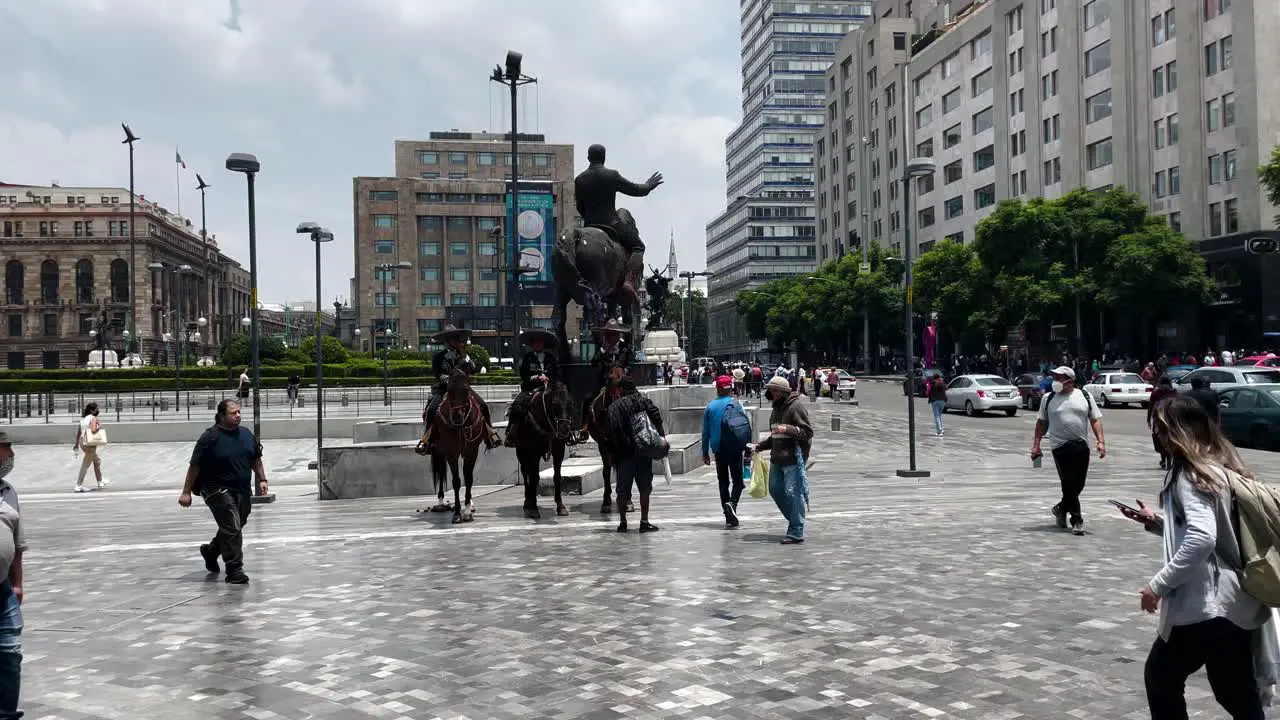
xmin=755 ymin=375 xmax=813 ymax=544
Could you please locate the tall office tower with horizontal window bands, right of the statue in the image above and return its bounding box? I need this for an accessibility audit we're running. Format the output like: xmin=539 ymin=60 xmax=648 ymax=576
xmin=707 ymin=0 xmax=872 ymax=357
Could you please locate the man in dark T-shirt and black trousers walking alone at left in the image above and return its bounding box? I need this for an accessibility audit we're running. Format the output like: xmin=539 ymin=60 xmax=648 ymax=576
xmin=178 ymin=400 xmax=266 ymax=585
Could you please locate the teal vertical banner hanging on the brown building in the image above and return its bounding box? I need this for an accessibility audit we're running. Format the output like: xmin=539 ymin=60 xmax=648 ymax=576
xmin=504 ymin=183 xmax=556 ymax=305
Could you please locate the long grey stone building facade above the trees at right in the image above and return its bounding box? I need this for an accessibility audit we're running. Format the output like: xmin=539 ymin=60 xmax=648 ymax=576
xmin=814 ymin=0 xmax=1280 ymax=261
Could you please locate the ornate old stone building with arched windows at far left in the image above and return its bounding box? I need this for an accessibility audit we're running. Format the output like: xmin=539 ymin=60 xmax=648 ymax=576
xmin=0 ymin=183 xmax=250 ymax=369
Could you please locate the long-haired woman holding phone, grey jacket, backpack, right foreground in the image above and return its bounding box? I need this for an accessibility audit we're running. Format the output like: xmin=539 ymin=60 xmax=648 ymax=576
xmin=1125 ymin=396 xmax=1271 ymax=720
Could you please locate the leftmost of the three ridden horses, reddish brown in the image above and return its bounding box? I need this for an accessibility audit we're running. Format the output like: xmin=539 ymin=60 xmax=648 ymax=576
xmin=431 ymin=370 xmax=485 ymax=523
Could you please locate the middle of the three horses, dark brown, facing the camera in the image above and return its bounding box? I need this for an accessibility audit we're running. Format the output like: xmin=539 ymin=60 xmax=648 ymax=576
xmin=516 ymin=380 xmax=577 ymax=520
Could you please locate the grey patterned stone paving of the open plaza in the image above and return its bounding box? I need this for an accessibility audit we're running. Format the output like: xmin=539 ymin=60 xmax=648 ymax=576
xmin=12 ymin=389 xmax=1280 ymax=720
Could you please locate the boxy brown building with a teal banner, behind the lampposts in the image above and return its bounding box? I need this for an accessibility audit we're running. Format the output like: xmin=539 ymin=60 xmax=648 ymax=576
xmin=352 ymin=131 xmax=581 ymax=357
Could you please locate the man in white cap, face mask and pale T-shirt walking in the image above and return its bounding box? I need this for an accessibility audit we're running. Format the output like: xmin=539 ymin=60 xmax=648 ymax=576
xmin=1032 ymin=365 xmax=1107 ymax=536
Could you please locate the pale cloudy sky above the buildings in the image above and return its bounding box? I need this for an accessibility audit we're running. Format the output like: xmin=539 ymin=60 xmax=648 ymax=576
xmin=0 ymin=0 xmax=741 ymax=302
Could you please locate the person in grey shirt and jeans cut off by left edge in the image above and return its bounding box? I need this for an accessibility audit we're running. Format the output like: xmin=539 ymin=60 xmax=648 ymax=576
xmin=0 ymin=432 xmax=27 ymax=720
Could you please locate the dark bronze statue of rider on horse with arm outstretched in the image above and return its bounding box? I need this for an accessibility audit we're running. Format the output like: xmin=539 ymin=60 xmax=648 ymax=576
xmin=552 ymin=145 xmax=662 ymax=361
